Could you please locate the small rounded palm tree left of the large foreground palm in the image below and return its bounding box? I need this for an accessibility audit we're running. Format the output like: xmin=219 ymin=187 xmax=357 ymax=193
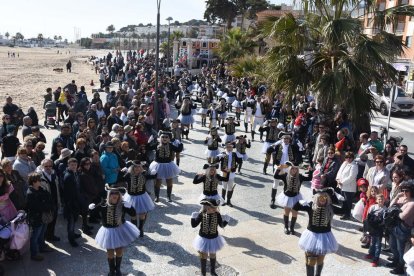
xmin=218 ymin=28 xmax=256 ymax=62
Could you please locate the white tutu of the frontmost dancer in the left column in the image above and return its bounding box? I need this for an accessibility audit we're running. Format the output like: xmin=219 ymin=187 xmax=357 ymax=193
xmin=95 ymin=221 xmax=139 ymax=249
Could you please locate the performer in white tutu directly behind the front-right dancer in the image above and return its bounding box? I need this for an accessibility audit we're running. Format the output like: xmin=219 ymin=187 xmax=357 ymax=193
xmin=270 ymin=162 xmax=311 ymax=235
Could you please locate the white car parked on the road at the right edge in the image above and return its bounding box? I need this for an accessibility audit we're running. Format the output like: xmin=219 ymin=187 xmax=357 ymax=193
xmin=369 ymin=84 xmax=414 ymax=115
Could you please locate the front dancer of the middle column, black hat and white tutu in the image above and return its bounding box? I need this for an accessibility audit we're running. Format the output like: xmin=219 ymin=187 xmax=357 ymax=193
xmin=191 ymin=199 xmax=230 ymax=276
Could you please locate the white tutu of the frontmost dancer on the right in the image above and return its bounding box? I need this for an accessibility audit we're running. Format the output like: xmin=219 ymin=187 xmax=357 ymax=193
xmin=299 ymin=229 xmax=338 ymax=255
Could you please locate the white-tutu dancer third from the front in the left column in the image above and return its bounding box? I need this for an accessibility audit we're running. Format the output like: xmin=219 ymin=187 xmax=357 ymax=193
xmin=149 ymin=131 xmax=182 ymax=202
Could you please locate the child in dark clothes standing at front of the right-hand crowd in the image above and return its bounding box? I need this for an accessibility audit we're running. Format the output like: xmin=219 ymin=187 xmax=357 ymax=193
xmin=365 ymin=194 xmax=387 ymax=267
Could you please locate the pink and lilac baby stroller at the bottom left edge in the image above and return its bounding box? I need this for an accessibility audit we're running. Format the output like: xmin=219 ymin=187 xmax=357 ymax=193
xmin=0 ymin=210 xmax=30 ymax=262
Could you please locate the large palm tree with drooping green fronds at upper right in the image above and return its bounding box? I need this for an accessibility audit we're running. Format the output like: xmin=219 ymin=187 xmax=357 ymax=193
xmin=262 ymin=0 xmax=413 ymax=132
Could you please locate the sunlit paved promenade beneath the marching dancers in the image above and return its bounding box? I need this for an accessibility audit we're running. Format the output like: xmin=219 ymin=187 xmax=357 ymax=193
xmin=3 ymin=92 xmax=389 ymax=276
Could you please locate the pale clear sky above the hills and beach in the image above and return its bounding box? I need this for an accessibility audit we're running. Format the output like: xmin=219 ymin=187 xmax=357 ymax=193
xmin=0 ymin=0 xmax=289 ymax=41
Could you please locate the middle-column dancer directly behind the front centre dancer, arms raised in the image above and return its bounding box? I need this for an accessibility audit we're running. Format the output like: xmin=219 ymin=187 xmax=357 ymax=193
xmin=193 ymin=163 xmax=229 ymax=204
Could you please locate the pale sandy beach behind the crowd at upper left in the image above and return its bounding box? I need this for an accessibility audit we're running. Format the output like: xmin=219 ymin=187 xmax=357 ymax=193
xmin=0 ymin=47 xmax=108 ymax=118
